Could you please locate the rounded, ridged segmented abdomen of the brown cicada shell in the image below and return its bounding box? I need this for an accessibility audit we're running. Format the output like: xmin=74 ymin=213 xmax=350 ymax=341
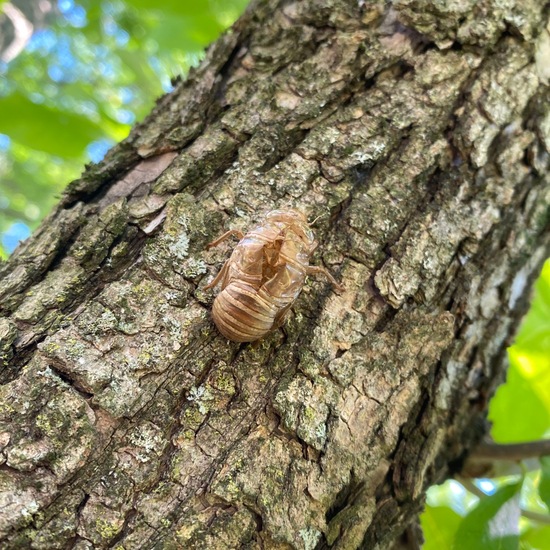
xmin=212 ymin=280 xmax=280 ymax=342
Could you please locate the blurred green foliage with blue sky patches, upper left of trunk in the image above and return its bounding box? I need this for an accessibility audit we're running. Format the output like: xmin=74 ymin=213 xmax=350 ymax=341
xmin=0 ymin=0 xmax=248 ymax=258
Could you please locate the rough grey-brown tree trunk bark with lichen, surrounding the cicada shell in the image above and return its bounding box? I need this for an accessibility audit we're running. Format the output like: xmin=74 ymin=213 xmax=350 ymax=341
xmin=0 ymin=0 xmax=550 ymax=550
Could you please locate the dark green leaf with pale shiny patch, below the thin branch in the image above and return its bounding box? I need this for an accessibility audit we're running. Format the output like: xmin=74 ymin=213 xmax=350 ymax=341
xmin=454 ymin=482 xmax=521 ymax=550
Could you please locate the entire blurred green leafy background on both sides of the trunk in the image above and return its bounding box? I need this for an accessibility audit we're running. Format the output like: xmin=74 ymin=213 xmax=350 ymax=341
xmin=0 ymin=0 xmax=550 ymax=550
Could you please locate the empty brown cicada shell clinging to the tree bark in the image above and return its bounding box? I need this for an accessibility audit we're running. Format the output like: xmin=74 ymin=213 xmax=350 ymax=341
xmin=205 ymin=209 xmax=341 ymax=342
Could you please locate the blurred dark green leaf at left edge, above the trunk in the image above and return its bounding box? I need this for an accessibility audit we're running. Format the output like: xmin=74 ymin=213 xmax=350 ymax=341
xmin=0 ymin=92 xmax=103 ymax=158
